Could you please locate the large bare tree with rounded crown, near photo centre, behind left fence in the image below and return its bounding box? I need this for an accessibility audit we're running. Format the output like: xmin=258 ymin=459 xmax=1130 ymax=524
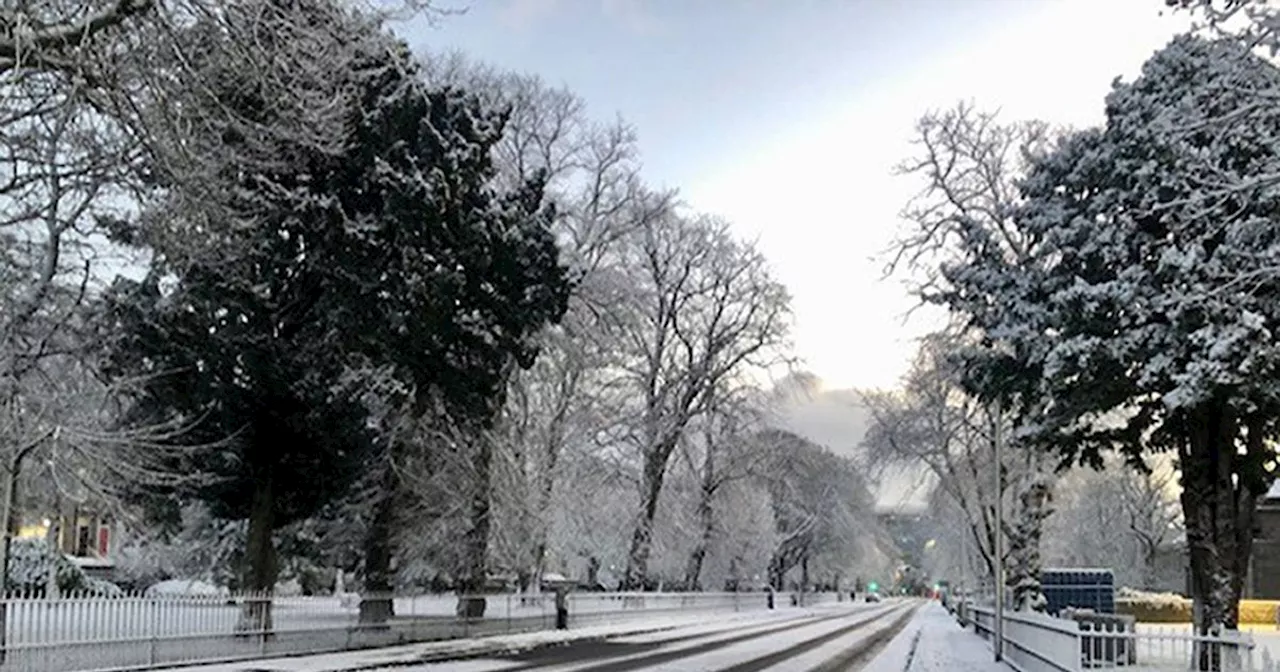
xmin=608 ymin=212 xmax=790 ymax=589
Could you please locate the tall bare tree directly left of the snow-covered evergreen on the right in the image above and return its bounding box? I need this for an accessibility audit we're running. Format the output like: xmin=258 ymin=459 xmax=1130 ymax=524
xmin=881 ymin=104 xmax=1070 ymax=607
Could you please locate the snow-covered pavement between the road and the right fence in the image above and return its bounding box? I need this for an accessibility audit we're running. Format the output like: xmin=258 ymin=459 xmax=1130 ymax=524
xmin=890 ymin=602 xmax=1009 ymax=672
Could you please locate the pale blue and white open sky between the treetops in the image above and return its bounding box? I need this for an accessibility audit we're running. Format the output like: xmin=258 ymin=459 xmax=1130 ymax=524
xmin=398 ymin=0 xmax=1187 ymax=501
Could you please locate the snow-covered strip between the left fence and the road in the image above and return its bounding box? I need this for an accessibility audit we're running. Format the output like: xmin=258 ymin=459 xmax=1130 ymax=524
xmin=157 ymin=605 xmax=832 ymax=672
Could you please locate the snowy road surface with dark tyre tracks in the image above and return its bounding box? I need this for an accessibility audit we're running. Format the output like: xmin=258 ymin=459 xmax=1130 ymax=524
xmin=360 ymin=600 xmax=920 ymax=672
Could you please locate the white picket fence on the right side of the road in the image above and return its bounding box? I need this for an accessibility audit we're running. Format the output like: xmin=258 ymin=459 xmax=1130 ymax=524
xmin=968 ymin=605 xmax=1277 ymax=672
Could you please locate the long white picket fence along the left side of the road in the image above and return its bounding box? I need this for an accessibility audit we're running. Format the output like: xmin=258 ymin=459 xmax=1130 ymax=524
xmin=0 ymin=593 xmax=836 ymax=672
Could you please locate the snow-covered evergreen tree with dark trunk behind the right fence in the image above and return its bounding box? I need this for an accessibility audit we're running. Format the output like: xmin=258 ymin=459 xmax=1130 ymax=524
xmin=901 ymin=36 xmax=1280 ymax=630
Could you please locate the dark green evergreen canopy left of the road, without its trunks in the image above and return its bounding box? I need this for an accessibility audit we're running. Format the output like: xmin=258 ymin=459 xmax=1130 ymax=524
xmin=106 ymin=2 xmax=570 ymax=583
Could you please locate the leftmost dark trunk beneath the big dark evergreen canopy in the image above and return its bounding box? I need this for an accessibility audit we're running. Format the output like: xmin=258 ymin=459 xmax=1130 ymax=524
xmin=238 ymin=466 xmax=278 ymax=636
